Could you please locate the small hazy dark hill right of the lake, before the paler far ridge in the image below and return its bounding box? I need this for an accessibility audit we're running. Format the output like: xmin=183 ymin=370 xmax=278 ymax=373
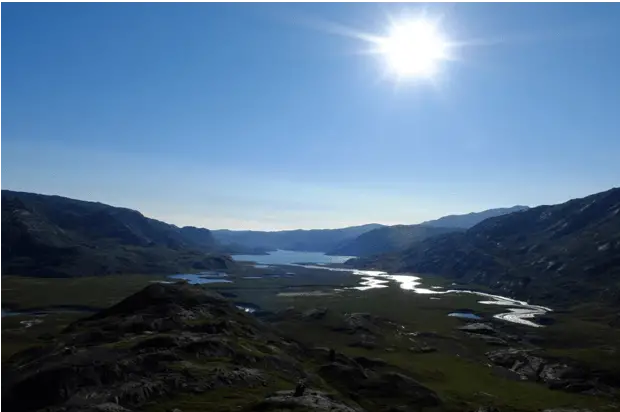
xmin=329 ymin=225 xmax=461 ymax=256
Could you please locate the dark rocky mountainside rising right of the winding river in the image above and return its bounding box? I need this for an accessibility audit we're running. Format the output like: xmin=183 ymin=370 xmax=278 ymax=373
xmin=351 ymin=188 xmax=620 ymax=305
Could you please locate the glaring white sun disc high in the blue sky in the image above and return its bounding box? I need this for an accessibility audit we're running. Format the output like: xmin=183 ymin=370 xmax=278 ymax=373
xmin=377 ymin=19 xmax=449 ymax=79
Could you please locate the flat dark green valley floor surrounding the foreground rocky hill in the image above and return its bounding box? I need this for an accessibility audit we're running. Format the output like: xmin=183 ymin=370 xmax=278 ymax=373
xmin=0 ymin=267 xmax=620 ymax=412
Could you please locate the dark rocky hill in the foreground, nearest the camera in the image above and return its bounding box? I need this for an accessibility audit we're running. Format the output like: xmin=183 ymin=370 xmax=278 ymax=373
xmin=0 ymin=284 xmax=442 ymax=412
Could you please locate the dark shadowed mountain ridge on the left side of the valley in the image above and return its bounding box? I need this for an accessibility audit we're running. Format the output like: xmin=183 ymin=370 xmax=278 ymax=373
xmin=0 ymin=191 xmax=233 ymax=276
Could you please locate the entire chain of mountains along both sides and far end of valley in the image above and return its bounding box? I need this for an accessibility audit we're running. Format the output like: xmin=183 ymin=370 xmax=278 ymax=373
xmin=9 ymin=185 xmax=620 ymax=302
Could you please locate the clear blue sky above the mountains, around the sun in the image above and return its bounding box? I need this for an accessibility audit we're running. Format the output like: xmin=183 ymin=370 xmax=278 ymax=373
xmin=0 ymin=3 xmax=620 ymax=229
